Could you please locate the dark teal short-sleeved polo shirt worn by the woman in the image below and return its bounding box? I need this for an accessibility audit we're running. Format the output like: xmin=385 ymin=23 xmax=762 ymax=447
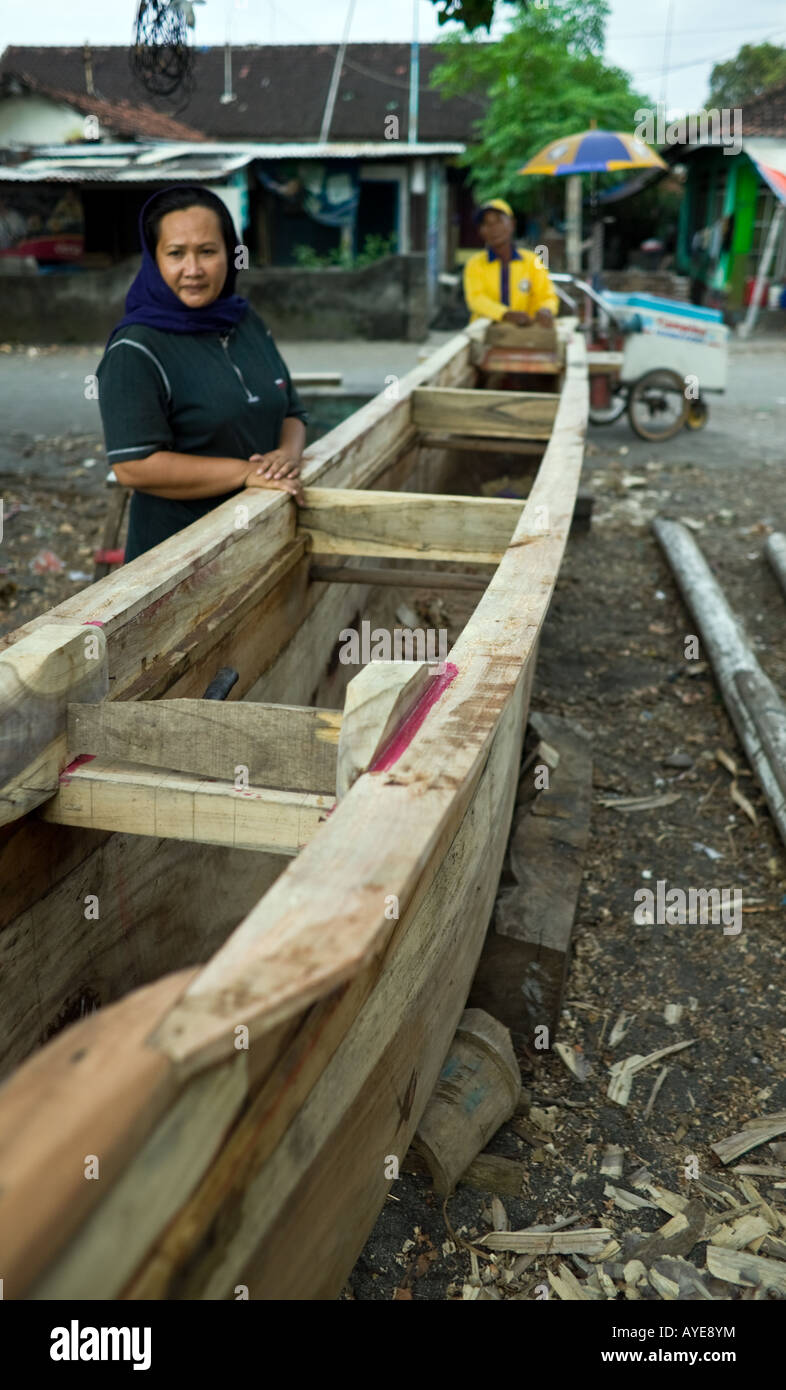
xmin=97 ymin=304 xmax=307 ymax=562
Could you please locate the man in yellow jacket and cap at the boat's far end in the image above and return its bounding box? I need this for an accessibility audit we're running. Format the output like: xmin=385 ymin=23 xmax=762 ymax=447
xmin=463 ymin=197 xmax=559 ymax=325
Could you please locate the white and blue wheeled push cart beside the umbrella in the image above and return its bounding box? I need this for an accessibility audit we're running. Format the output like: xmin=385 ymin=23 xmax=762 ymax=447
xmin=551 ymin=274 xmax=729 ymax=442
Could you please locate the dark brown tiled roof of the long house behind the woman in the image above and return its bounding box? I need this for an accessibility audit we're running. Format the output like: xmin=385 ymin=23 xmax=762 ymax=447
xmin=0 ymin=43 xmax=486 ymax=143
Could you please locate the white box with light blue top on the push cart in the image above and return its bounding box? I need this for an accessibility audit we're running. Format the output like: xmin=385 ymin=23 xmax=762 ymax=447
xmin=602 ymin=291 xmax=729 ymax=392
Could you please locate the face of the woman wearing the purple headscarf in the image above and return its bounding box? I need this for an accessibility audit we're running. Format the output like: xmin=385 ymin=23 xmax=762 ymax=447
xmin=156 ymin=207 xmax=227 ymax=309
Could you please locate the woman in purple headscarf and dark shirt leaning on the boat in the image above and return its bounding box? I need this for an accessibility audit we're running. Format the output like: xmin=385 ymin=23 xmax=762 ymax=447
xmin=97 ymin=185 xmax=307 ymax=562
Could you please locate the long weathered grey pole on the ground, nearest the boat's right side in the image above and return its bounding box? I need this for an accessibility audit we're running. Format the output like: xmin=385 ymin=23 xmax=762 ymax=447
xmin=652 ymin=517 xmax=786 ymax=844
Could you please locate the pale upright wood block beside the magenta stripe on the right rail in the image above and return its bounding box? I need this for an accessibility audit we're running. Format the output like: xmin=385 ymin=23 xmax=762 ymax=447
xmin=335 ymin=662 xmax=437 ymax=798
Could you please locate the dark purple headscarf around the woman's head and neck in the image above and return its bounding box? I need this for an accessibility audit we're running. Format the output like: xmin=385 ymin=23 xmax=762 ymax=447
xmin=104 ymin=183 xmax=249 ymax=350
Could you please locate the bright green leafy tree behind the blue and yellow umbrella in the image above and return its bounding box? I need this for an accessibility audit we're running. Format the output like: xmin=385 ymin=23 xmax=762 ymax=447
xmin=433 ymin=0 xmax=652 ymax=209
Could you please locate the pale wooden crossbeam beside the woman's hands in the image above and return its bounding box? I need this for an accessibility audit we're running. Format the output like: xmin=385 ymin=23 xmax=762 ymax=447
xmin=298 ymin=483 xmax=524 ymax=564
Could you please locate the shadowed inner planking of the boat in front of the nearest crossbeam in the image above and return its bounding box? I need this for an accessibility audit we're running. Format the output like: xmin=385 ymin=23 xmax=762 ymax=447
xmin=0 ymin=819 xmax=287 ymax=1084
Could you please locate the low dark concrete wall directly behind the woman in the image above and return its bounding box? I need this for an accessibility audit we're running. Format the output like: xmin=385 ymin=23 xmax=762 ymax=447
xmin=0 ymin=248 xmax=427 ymax=343
